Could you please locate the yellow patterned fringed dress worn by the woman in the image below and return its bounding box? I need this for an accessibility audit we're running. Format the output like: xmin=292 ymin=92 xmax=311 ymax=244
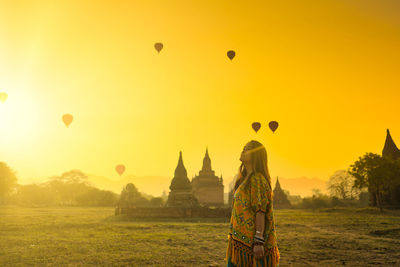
xmin=224 ymin=172 xmax=280 ymax=267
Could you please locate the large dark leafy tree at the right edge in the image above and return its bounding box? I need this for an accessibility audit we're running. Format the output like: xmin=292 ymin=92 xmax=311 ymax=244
xmin=348 ymin=153 xmax=400 ymax=212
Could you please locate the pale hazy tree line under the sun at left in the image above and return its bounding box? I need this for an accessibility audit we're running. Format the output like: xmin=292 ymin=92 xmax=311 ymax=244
xmin=0 ymin=166 xmax=164 ymax=207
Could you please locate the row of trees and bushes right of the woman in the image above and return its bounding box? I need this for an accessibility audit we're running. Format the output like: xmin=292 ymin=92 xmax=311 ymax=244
xmin=286 ymin=152 xmax=400 ymax=212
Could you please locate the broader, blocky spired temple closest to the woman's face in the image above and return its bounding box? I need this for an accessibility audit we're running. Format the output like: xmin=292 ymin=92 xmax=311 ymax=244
xmin=192 ymin=147 xmax=224 ymax=206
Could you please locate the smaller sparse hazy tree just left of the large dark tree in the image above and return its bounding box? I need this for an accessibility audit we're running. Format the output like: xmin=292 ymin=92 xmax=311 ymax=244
xmin=327 ymin=170 xmax=360 ymax=199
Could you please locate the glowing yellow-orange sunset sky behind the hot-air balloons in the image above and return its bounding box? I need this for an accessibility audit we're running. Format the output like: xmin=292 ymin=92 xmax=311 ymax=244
xmin=0 ymin=0 xmax=400 ymax=197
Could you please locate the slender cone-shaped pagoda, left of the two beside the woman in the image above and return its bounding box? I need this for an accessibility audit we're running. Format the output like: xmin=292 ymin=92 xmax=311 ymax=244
xmin=166 ymin=151 xmax=198 ymax=207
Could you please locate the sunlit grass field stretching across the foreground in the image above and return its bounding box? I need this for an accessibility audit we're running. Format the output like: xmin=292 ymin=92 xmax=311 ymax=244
xmin=0 ymin=207 xmax=400 ymax=266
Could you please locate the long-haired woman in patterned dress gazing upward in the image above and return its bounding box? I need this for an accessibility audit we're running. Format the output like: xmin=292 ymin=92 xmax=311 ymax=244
xmin=225 ymin=140 xmax=280 ymax=267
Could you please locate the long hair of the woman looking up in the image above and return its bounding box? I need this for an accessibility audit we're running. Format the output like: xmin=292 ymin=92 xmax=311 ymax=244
xmin=234 ymin=140 xmax=272 ymax=191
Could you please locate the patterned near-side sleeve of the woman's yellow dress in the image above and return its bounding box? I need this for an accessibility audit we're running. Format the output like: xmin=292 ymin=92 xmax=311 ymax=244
xmin=250 ymin=172 xmax=271 ymax=212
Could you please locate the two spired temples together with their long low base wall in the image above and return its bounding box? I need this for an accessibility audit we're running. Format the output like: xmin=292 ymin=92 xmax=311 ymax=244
xmin=115 ymin=148 xmax=232 ymax=218
